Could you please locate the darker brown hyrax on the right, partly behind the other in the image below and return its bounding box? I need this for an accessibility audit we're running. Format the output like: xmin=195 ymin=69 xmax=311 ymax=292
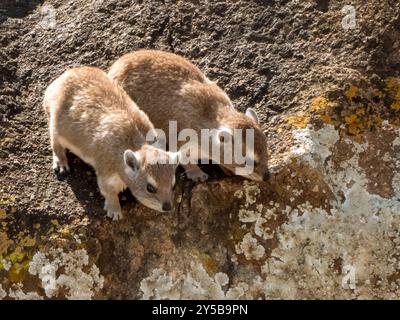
xmin=108 ymin=50 xmax=269 ymax=181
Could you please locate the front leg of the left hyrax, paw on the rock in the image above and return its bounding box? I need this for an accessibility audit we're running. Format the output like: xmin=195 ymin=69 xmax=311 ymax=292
xmin=97 ymin=173 xmax=122 ymax=220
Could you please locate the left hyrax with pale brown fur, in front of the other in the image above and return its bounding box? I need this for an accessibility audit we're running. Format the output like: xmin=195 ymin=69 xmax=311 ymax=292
xmin=43 ymin=67 xmax=178 ymax=220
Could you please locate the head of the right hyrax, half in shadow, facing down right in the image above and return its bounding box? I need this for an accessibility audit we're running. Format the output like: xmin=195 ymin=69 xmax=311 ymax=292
xmin=214 ymin=109 xmax=270 ymax=181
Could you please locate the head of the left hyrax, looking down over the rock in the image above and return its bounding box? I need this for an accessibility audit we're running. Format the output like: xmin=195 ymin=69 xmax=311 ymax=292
xmin=124 ymin=145 xmax=179 ymax=212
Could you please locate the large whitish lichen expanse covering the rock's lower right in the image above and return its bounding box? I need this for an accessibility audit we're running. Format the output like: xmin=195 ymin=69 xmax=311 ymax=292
xmin=262 ymin=126 xmax=400 ymax=299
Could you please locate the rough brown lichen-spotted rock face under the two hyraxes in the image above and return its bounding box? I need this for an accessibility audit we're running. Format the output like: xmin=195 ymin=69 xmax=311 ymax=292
xmin=0 ymin=0 xmax=400 ymax=299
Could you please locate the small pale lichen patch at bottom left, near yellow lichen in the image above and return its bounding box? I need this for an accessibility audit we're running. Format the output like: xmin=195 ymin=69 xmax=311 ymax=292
xmin=29 ymin=249 xmax=103 ymax=300
